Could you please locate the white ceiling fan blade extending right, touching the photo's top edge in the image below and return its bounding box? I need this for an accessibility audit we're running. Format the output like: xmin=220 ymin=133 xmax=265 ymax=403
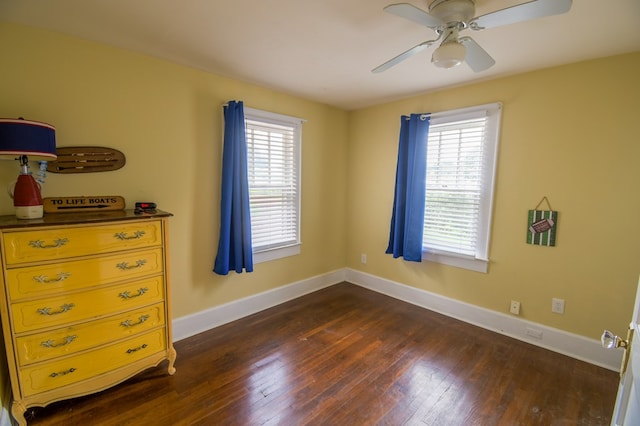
xmin=469 ymin=0 xmax=571 ymax=30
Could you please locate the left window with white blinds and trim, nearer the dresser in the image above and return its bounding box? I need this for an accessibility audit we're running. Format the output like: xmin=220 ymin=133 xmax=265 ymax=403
xmin=244 ymin=107 xmax=302 ymax=263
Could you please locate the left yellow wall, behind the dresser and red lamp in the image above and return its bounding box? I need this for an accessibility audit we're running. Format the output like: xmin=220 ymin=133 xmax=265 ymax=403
xmin=0 ymin=24 xmax=348 ymax=318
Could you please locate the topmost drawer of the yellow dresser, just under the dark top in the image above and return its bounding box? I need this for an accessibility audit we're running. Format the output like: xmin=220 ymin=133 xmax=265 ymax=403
xmin=2 ymin=221 xmax=162 ymax=266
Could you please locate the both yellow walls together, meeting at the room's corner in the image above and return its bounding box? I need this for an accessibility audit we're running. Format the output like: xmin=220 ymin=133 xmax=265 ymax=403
xmin=0 ymin=24 xmax=640 ymax=360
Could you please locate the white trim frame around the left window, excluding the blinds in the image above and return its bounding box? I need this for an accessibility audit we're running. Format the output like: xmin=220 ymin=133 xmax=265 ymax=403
xmin=244 ymin=106 xmax=306 ymax=264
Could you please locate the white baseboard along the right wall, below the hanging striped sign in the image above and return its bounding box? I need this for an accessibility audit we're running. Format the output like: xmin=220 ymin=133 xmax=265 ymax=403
xmin=345 ymin=269 xmax=622 ymax=371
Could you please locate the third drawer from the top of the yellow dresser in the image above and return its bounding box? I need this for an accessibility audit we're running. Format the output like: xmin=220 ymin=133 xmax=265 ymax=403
xmin=11 ymin=276 xmax=164 ymax=333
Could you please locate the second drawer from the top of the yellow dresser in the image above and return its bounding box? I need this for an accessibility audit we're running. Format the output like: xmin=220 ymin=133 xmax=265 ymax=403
xmin=6 ymin=248 xmax=163 ymax=302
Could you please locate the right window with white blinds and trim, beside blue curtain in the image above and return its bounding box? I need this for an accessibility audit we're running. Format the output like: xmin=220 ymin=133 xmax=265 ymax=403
xmin=422 ymin=104 xmax=501 ymax=272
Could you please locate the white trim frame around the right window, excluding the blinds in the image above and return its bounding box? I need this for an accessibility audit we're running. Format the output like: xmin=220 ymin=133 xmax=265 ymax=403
xmin=422 ymin=102 xmax=502 ymax=273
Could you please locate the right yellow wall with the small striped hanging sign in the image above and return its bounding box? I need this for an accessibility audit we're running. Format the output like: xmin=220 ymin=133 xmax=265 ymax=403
xmin=347 ymin=53 xmax=640 ymax=338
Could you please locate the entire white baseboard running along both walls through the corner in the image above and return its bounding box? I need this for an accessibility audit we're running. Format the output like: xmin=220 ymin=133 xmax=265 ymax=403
xmin=173 ymin=269 xmax=622 ymax=371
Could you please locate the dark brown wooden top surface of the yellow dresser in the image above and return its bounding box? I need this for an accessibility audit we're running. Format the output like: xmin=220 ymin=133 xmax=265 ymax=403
xmin=0 ymin=210 xmax=173 ymax=229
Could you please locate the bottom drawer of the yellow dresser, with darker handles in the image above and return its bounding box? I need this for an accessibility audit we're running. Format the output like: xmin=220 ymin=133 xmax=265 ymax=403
xmin=18 ymin=329 xmax=167 ymax=396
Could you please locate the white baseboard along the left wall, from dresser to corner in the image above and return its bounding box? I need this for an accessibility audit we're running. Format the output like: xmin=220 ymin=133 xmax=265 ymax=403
xmin=172 ymin=269 xmax=346 ymax=341
